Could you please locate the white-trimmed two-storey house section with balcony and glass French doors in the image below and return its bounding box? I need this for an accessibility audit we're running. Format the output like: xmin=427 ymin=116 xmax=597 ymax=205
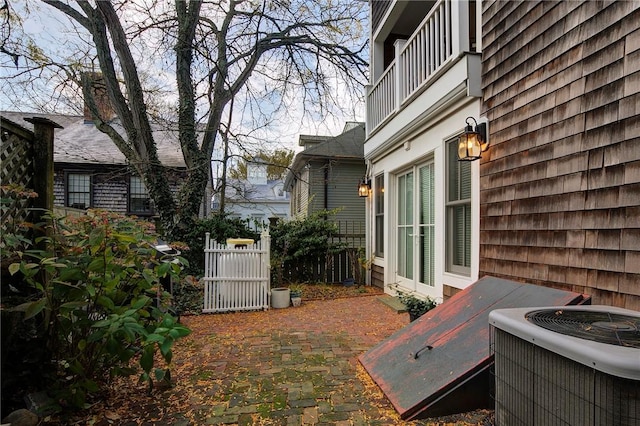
xmin=364 ymin=0 xmax=483 ymax=300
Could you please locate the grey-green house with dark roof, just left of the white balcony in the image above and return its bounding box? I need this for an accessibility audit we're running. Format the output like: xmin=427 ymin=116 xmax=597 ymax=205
xmin=284 ymin=122 xmax=366 ymax=223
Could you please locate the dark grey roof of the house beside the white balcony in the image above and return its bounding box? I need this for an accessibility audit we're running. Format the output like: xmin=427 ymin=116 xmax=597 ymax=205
xmin=284 ymin=123 xmax=365 ymax=188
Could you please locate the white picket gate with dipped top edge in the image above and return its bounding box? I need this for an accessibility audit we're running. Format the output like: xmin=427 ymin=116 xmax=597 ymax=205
xmin=202 ymin=232 xmax=271 ymax=313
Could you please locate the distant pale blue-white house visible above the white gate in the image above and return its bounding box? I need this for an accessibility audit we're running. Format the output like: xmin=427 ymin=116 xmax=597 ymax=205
xmin=212 ymin=158 xmax=289 ymax=229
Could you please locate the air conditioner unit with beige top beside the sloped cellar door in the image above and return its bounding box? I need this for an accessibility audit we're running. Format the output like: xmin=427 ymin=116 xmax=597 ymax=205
xmin=489 ymin=305 xmax=640 ymax=426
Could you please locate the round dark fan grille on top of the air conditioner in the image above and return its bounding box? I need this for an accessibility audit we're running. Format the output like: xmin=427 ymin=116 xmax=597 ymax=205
xmin=525 ymin=309 xmax=640 ymax=349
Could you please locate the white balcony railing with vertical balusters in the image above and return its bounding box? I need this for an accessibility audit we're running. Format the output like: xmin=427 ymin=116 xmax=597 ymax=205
xmin=367 ymin=0 xmax=470 ymax=133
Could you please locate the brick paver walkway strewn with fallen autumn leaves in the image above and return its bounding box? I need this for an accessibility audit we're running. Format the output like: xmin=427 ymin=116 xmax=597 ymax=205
xmin=72 ymin=296 xmax=496 ymax=426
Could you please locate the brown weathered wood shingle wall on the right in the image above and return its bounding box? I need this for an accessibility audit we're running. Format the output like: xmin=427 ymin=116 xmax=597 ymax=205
xmin=480 ymin=1 xmax=640 ymax=310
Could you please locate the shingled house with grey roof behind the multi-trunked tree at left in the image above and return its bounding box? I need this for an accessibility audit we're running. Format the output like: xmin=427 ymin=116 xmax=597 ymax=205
xmin=0 ymin=111 xmax=185 ymax=217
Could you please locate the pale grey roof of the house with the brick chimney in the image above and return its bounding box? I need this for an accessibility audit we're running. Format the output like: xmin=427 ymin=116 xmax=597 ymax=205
xmin=0 ymin=111 xmax=185 ymax=167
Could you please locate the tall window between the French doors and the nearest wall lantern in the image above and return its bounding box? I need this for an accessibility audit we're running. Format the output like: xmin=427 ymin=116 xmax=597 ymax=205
xmin=446 ymin=139 xmax=471 ymax=276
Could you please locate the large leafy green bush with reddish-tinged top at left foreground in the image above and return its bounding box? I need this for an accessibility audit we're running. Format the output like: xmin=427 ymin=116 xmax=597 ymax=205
xmin=2 ymin=211 xmax=189 ymax=409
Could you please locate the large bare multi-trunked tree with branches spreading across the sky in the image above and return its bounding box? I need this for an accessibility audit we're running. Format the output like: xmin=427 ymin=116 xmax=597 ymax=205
xmin=0 ymin=0 xmax=368 ymax=240
